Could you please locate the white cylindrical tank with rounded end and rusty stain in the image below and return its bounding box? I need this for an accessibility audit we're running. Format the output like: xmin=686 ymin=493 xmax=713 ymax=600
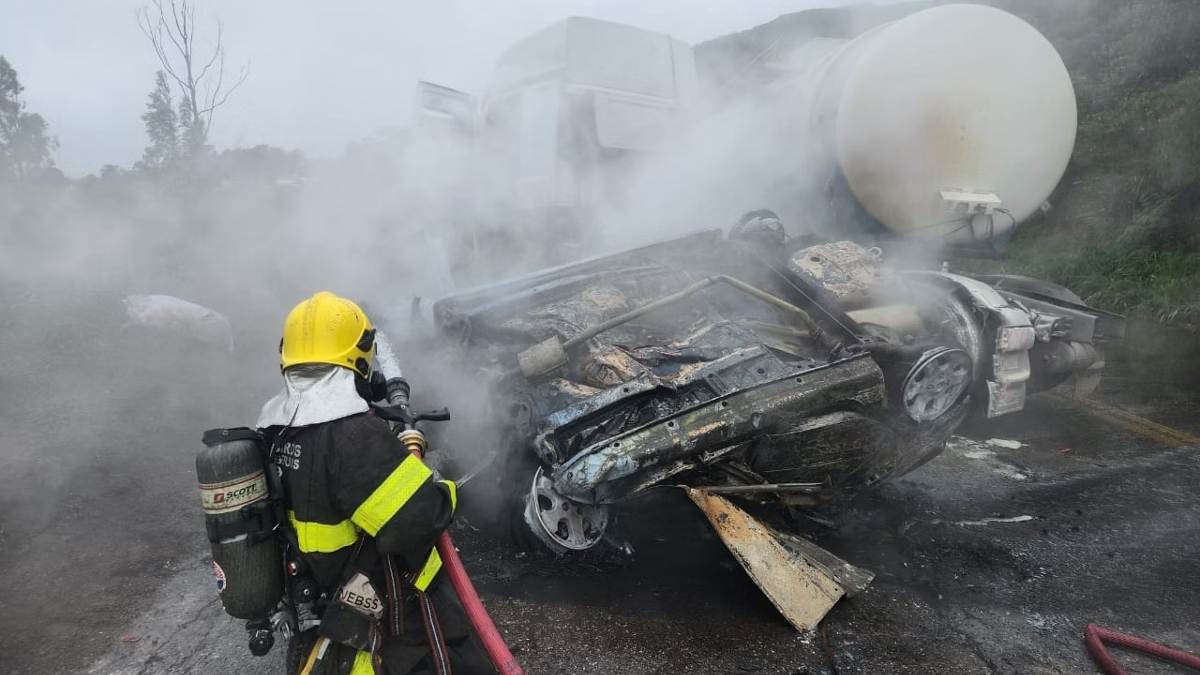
xmin=788 ymin=5 xmax=1078 ymax=240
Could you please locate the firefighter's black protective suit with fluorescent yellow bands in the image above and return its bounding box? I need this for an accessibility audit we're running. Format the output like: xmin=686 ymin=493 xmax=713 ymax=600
xmin=264 ymin=413 xmax=493 ymax=675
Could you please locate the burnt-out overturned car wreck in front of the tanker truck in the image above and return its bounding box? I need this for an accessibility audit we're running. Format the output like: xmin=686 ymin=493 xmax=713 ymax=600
xmin=424 ymin=225 xmax=1117 ymax=554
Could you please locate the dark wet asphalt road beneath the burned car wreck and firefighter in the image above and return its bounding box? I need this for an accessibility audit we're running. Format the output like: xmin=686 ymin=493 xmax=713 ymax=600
xmin=0 ymin=345 xmax=1200 ymax=675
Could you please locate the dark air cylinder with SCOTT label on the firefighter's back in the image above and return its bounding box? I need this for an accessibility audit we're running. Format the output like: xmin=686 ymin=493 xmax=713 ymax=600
xmin=196 ymin=429 xmax=283 ymax=621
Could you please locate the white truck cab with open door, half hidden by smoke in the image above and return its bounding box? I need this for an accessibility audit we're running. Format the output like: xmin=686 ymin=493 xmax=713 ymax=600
xmin=418 ymin=17 xmax=696 ymax=281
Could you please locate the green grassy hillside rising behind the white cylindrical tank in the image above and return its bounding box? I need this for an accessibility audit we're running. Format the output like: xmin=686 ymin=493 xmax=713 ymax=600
xmin=696 ymin=0 xmax=1200 ymax=323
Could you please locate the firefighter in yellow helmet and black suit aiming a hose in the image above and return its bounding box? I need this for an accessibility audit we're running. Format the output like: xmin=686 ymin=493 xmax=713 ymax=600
xmin=258 ymin=292 xmax=493 ymax=675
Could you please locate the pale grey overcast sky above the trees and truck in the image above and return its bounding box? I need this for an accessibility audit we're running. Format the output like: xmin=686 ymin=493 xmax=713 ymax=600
xmin=0 ymin=0 xmax=868 ymax=177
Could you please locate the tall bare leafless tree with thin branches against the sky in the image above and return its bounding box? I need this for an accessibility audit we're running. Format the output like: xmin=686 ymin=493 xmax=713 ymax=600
xmin=138 ymin=0 xmax=247 ymax=156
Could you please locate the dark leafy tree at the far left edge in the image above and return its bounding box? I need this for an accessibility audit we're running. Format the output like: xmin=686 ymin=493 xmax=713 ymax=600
xmin=0 ymin=56 xmax=59 ymax=178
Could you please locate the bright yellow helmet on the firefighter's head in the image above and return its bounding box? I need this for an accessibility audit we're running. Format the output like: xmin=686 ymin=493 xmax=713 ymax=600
xmin=280 ymin=291 xmax=374 ymax=377
